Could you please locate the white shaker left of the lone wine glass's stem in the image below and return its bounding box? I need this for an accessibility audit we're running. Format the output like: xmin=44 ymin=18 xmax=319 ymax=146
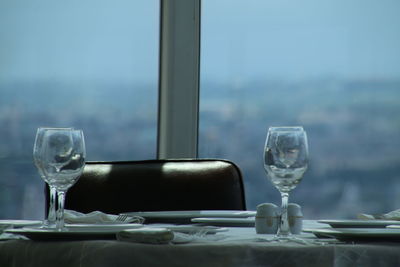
xmin=255 ymin=203 xmax=279 ymax=234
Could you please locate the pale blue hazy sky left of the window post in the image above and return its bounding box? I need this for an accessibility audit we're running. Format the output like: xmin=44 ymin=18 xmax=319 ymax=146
xmin=0 ymin=0 xmax=159 ymax=82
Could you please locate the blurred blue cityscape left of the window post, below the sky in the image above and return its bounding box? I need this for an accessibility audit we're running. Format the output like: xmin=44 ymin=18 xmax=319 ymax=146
xmin=0 ymin=82 xmax=157 ymax=219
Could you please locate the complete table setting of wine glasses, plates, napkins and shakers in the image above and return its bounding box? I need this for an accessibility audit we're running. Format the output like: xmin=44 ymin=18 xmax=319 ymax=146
xmin=5 ymin=126 xmax=400 ymax=244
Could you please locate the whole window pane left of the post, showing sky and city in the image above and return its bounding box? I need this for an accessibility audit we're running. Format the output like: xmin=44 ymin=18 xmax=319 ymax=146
xmin=0 ymin=0 xmax=159 ymax=219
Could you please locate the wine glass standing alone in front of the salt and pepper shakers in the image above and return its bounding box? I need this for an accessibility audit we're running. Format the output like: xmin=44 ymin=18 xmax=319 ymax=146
xmin=264 ymin=126 xmax=308 ymax=240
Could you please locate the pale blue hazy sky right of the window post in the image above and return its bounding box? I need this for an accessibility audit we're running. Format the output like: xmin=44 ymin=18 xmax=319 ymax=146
xmin=202 ymin=0 xmax=400 ymax=80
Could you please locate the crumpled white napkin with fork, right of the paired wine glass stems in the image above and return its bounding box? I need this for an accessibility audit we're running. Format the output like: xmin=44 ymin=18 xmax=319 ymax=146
xmin=64 ymin=210 xmax=144 ymax=224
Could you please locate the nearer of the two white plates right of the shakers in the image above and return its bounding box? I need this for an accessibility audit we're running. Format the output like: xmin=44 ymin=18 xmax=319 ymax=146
xmin=303 ymin=228 xmax=400 ymax=242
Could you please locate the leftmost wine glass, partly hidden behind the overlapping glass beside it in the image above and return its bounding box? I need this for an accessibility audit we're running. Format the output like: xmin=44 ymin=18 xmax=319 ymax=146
xmin=33 ymin=127 xmax=71 ymax=228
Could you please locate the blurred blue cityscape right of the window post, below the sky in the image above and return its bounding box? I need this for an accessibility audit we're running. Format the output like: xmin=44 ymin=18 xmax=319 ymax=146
xmin=199 ymin=79 xmax=400 ymax=218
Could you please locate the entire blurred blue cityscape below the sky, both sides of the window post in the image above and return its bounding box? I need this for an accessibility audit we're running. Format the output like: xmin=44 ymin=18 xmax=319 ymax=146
xmin=0 ymin=79 xmax=400 ymax=219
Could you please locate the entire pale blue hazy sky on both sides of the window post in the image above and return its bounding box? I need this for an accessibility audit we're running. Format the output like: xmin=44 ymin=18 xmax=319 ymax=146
xmin=0 ymin=0 xmax=400 ymax=84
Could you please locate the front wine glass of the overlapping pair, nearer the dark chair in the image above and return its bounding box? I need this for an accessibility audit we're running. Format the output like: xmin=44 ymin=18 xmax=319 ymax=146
xmin=43 ymin=129 xmax=86 ymax=231
